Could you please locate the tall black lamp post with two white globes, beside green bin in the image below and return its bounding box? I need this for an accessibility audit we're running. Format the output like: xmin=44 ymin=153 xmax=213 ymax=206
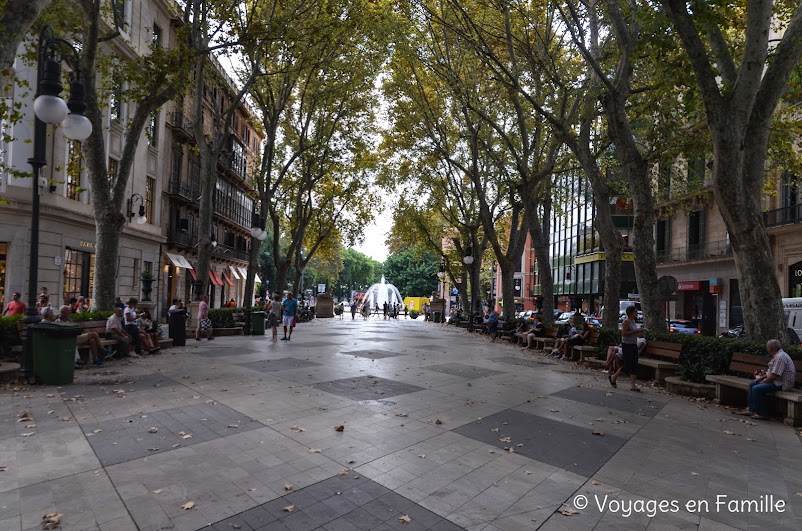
xmin=20 ymin=24 xmax=92 ymax=383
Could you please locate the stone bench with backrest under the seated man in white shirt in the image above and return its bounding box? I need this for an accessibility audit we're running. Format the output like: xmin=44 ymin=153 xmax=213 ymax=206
xmin=705 ymin=352 xmax=802 ymax=426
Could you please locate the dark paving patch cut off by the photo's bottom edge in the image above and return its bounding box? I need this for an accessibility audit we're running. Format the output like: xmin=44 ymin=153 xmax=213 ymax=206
xmin=211 ymin=476 xmax=462 ymax=531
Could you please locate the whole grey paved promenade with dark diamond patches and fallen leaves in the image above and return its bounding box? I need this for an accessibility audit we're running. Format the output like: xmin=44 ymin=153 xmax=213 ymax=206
xmin=0 ymin=315 xmax=802 ymax=531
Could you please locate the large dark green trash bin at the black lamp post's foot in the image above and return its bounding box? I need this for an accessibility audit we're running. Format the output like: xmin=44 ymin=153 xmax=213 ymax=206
xmin=30 ymin=323 xmax=81 ymax=385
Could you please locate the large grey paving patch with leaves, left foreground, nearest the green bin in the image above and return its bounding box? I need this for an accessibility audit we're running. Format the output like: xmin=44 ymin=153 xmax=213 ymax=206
xmin=81 ymin=403 xmax=264 ymax=466
